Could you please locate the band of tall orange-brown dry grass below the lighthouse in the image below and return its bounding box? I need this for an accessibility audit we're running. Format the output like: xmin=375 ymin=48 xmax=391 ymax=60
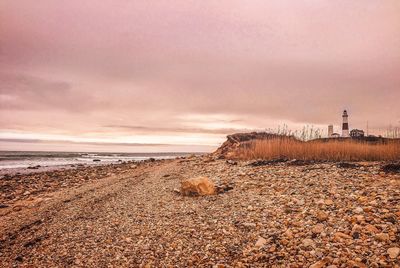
xmin=238 ymin=138 xmax=400 ymax=161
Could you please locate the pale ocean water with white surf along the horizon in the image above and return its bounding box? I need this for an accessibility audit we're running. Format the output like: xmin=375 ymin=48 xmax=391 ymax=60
xmin=0 ymin=151 xmax=194 ymax=170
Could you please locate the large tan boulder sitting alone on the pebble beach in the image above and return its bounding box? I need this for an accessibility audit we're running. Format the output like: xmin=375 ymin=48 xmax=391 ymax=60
xmin=181 ymin=177 xmax=216 ymax=196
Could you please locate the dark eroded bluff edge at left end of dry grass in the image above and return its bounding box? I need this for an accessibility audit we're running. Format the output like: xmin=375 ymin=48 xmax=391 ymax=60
xmin=213 ymin=132 xmax=288 ymax=159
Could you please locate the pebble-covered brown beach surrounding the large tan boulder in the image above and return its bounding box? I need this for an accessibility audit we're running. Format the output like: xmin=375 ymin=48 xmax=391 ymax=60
xmin=0 ymin=155 xmax=400 ymax=268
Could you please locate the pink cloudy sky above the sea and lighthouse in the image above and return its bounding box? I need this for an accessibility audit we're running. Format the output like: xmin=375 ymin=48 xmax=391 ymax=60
xmin=0 ymin=0 xmax=400 ymax=152
